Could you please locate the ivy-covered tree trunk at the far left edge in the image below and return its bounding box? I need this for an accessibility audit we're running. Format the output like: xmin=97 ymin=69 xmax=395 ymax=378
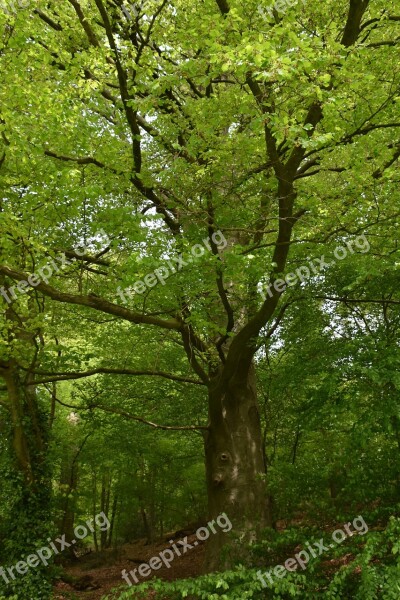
xmin=0 ymin=360 xmax=52 ymax=599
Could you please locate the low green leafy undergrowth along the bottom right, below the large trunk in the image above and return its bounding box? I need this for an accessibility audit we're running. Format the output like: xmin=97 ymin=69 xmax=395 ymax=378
xmin=104 ymin=517 xmax=400 ymax=600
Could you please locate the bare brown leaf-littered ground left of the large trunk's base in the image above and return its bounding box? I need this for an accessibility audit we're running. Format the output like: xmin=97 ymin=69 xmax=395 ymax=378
xmin=53 ymin=532 xmax=204 ymax=600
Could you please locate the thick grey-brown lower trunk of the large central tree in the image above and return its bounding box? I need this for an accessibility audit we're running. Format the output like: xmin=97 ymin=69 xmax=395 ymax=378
xmin=205 ymin=365 xmax=270 ymax=571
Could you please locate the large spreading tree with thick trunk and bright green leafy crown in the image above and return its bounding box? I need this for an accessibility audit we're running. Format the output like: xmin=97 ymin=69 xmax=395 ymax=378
xmin=0 ymin=0 xmax=400 ymax=568
